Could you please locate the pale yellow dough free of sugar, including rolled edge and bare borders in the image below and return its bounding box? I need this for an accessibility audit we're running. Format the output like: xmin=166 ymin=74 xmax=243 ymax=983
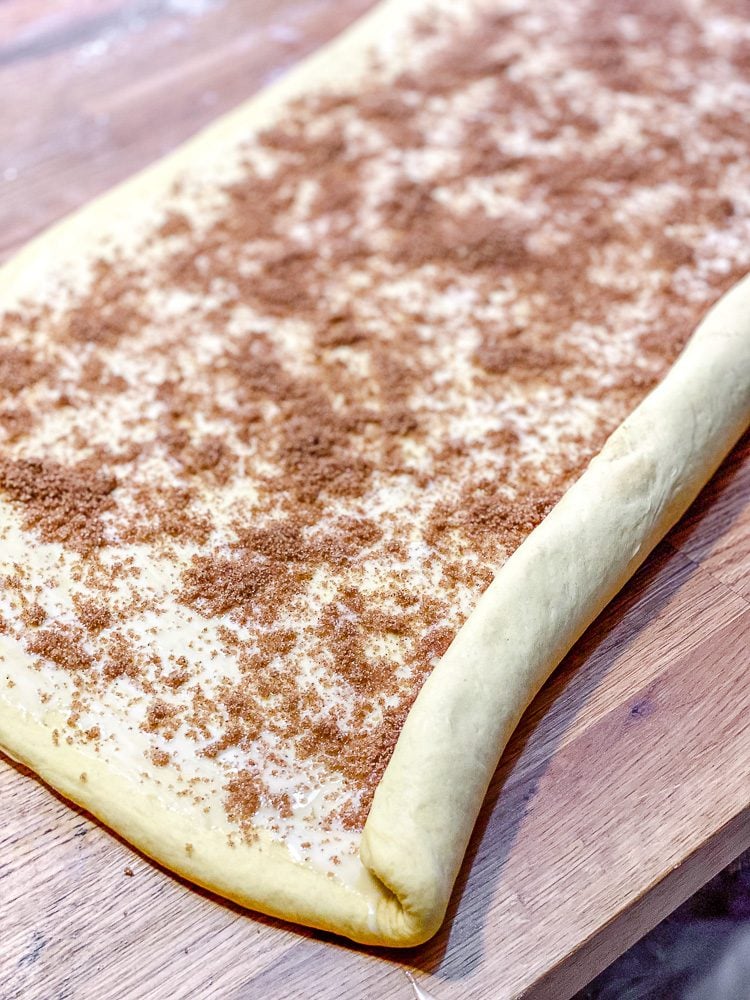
xmin=0 ymin=0 xmax=750 ymax=946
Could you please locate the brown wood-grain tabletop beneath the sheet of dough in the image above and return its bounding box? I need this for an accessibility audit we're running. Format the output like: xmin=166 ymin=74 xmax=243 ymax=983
xmin=0 ymin=0 xmax=750 ymax=1000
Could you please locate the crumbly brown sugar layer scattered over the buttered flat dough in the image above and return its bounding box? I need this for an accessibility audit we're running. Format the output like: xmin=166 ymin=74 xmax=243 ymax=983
xmin=0 ymin=0 xmax=750 ymax=854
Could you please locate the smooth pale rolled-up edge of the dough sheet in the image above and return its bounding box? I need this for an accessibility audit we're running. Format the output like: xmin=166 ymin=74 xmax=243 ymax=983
xmin=360 ymin=276 xmax=750 ymax=936
